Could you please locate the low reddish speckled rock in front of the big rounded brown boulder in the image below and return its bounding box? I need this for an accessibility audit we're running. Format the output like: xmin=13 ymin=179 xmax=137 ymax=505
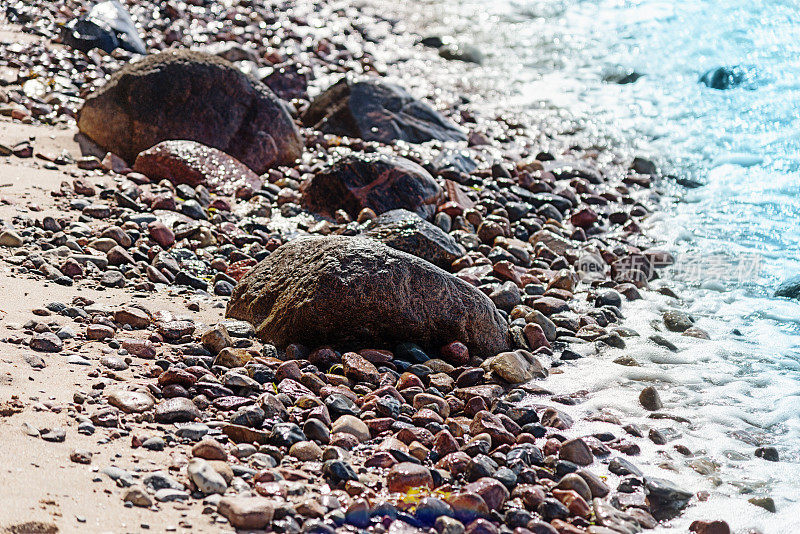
xmin=133 ymin=141 xmax=262 ymax=195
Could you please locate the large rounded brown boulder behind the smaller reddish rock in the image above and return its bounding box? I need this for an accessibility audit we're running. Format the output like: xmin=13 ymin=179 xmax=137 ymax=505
xmin=78 ymin=50 xmax=303 ymax=173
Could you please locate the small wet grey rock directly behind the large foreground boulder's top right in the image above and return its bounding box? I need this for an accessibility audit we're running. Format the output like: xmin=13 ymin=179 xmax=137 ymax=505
xmin=365 ymin=210 xmax=466 ymax=270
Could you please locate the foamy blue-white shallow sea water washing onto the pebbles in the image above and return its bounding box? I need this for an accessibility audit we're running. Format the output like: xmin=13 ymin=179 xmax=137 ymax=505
xmin=410 ymin=0 xmax=800 ymax=533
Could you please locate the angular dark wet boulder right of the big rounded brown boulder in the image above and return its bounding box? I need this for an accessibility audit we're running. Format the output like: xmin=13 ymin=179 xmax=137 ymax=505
xmin=302 ymin=78 xmax=466 ymax=144
